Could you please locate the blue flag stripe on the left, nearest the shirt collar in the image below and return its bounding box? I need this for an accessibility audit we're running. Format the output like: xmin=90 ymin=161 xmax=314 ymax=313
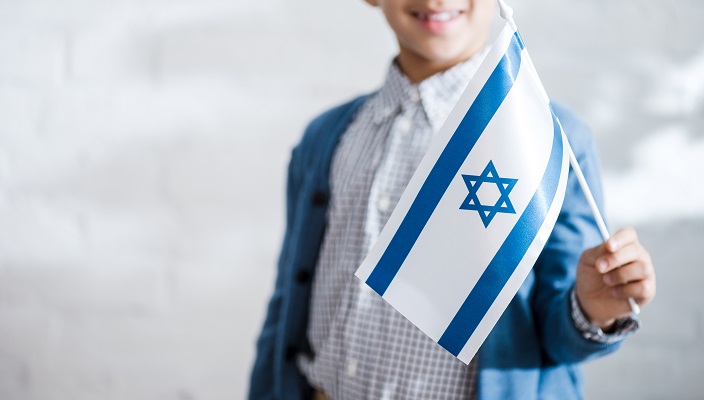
xmin=366 ymin=34 xmax=523 ymax=296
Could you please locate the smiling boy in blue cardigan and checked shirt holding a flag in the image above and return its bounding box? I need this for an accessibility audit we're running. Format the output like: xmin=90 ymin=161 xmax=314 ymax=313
xmin=249 ymin=0 xmax=655 ymax=399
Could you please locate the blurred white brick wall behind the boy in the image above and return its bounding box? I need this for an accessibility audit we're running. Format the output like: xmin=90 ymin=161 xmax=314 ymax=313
xmin=0 ymin=0 xmax=704 ymax=400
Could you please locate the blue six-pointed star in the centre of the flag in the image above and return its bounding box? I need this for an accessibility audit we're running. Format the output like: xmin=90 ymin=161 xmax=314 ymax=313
xmin=460 ymin=161 xmax=518 ymax=228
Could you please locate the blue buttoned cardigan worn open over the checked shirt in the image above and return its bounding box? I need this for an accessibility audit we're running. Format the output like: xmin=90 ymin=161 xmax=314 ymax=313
xmin=249 ymin=96 xmax=620 ymax=400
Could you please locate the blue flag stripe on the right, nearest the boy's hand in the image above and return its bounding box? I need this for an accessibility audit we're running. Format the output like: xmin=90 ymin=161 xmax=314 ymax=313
xmin=438 ymin=114 xmax=563 ymax=357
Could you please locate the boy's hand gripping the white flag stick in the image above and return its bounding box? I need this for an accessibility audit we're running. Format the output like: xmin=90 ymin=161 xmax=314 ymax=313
xmin=575 ymin=228 xmax=655 ymax=331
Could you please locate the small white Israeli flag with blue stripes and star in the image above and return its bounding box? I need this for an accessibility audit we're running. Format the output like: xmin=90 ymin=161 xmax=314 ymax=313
xmin=355 ymin=25 xmax=569 ymax=363
